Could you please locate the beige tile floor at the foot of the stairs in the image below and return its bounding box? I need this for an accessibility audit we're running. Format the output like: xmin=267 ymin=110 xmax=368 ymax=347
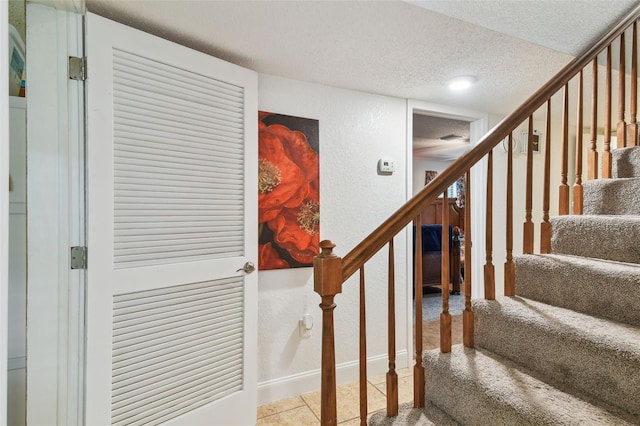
xmin=258 ymin=316 xmax=462 ymax=426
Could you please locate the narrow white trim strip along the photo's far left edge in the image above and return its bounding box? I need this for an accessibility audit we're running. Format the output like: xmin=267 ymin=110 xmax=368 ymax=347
xmin=0 ymin=2 xmax=9 ymax=420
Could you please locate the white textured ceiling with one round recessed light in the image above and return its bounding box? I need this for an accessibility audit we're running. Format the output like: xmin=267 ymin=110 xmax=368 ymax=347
xmin=87 ymin=0 xmax=638 ymax=160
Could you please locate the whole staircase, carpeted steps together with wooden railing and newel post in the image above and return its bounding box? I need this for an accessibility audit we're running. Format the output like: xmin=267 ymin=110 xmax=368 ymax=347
xmin=314 ymin=3 xmax=640 ymax=426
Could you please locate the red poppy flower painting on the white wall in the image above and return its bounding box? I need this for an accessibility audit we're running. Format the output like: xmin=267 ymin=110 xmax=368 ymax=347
xmin=258 ymin=111 xmax=320 ymax=270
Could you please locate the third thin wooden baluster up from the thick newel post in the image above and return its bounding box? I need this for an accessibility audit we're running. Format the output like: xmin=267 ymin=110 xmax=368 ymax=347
xmin=413 ymin=215 xmax=424 ymax=408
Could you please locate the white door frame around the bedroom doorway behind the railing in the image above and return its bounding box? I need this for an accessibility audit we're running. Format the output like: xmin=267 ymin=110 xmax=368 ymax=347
xmin=405 ymin=100 xmax=489 ymax=362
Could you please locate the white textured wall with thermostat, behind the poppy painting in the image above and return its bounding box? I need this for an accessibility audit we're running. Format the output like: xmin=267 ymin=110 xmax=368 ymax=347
xmin=258 ymin=75 xmax=408 ymax=404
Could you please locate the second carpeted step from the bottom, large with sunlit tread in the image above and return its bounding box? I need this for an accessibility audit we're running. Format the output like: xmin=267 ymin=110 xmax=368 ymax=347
xmin=424 ymin=345 xmax=640 ymax=426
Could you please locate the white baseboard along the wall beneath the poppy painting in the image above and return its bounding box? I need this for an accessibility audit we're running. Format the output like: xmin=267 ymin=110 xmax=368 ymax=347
xmin=258 ymin=350 xmax=413 ymax=405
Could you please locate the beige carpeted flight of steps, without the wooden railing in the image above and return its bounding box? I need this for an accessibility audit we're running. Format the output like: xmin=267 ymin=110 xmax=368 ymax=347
xmin=370 ymin=147 xmax=640 ymax=425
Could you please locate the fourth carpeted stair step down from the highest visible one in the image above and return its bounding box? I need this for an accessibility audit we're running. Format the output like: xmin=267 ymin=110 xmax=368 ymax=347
xmin=514 ymin=254 xmax=640 ymax=327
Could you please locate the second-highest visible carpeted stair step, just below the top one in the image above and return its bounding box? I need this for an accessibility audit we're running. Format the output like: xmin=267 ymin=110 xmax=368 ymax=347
xmin=583 ymin=177 xmax=640 ymax=216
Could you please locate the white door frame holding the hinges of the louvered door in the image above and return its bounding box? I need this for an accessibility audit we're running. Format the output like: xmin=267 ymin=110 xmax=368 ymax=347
xmin=27 ymin=2 xmax=84 ymax=425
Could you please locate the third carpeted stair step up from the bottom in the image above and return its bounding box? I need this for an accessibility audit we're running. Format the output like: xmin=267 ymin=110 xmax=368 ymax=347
xmin=473 ymin=297 xmax=640 ymax=415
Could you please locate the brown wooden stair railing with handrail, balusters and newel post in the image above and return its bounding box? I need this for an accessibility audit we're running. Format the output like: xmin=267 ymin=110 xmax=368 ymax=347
xmin=314 ymin=2 xmax=640 ymax=425
